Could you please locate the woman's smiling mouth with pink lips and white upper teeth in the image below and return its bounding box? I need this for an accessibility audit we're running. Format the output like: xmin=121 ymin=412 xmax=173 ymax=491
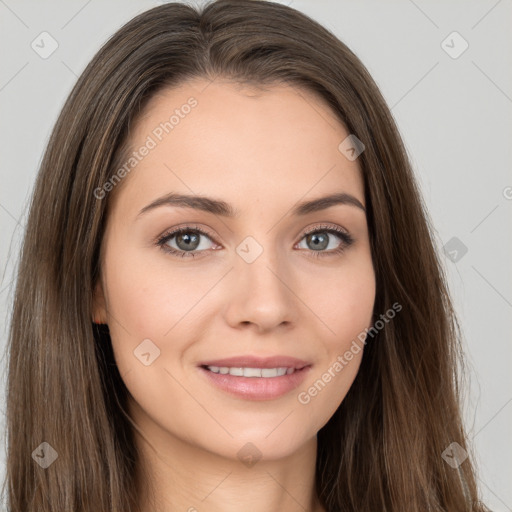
xmin=198 ymin=357 xmax=312 ymax=400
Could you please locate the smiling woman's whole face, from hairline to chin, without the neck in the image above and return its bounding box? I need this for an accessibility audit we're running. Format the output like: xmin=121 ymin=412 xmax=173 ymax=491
xmin=96 ymin=79 xmax=375 ymax=459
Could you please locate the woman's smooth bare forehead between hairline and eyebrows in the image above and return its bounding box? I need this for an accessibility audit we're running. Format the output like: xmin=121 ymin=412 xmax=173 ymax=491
xmin=114 ymin=79 xmax=364 ymax=215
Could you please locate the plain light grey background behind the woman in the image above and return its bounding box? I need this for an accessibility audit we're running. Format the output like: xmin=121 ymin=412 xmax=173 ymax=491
xmin=0 ymin=0 xmax=512 ymax=511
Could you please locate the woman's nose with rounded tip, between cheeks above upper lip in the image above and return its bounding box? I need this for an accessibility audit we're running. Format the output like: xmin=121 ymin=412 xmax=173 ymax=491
xmin=225 ymin=245 xmax=301 ymax=333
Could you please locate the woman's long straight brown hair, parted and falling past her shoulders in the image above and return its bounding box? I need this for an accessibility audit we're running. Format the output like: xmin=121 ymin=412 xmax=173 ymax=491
xmin=4 ymin=0 xmax=488 ymax=512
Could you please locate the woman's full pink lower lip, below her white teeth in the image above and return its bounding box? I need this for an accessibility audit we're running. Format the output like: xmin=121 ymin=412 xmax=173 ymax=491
xmin=199 ymin=366 xmax=311 ymax=400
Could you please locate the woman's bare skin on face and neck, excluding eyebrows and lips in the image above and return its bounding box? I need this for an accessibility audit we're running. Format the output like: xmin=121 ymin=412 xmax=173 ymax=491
xmin=95 ymin=78 xmax=375 ymax=512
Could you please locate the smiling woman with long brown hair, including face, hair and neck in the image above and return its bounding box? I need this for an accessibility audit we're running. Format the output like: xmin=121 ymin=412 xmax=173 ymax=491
xmin=5 ymin=0 xmax=487 ymax=512
